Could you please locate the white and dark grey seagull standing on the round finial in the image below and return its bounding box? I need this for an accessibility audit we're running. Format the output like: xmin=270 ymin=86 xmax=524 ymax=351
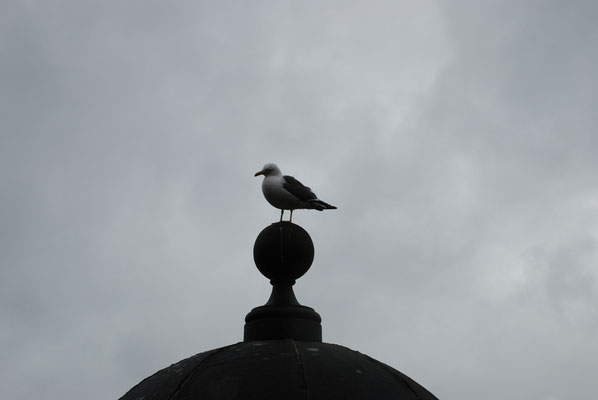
xmin=255 ymin=163 xmax=336 ymax=222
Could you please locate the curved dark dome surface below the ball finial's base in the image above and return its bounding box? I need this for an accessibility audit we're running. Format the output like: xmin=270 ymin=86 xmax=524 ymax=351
xmin=121 ymin=339 xmax=436 ymax=400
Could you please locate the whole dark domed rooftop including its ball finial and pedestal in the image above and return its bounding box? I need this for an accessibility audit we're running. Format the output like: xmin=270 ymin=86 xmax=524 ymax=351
xmin=121 ymin=221 xmax=436 ymax=400
